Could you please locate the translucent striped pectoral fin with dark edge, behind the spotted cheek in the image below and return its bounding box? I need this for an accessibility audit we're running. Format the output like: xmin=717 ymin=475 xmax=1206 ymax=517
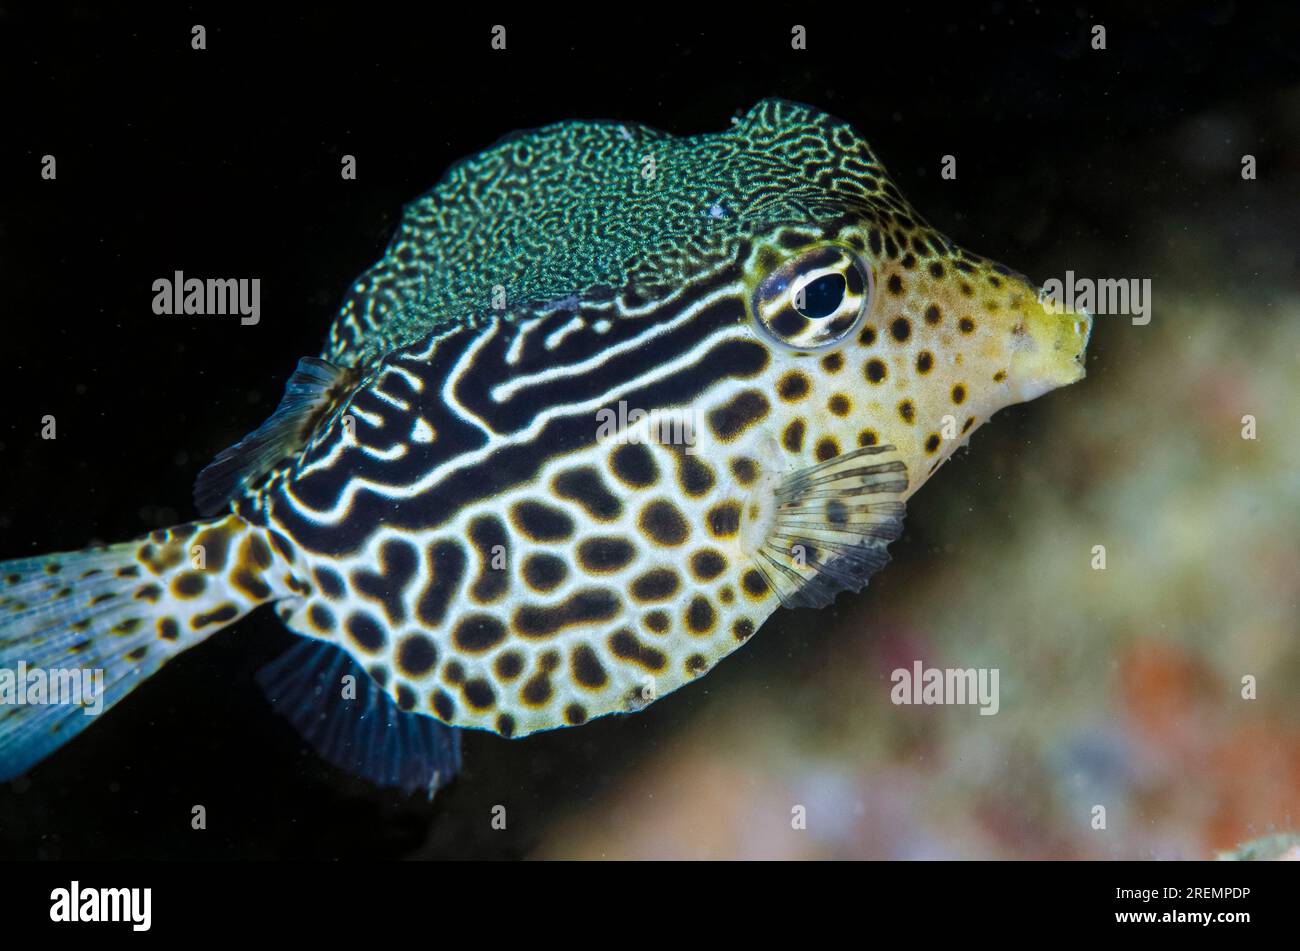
xmin=755 ymin=446 xmax=907 ymax=608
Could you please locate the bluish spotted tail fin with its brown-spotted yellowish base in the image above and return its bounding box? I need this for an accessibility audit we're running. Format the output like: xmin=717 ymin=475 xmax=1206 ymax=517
xmin=0 ymin=514 xmax=283 ymax=782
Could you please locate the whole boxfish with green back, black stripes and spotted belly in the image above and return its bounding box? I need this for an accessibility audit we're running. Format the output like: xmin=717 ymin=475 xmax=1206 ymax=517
xmin=0 ymin=100 xmax=1091 ymax=786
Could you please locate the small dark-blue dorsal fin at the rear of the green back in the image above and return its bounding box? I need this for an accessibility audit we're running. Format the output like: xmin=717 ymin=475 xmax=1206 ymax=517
xmin=194 ymin=357 xmax=360 ymax=514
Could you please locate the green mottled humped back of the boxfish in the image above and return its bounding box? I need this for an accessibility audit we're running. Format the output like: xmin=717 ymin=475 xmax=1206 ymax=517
xmin=324 ymin=99 xmax=902 ymax=364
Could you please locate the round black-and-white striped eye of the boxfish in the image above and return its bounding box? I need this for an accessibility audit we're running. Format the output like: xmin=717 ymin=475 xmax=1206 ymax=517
xmin=751 ymin=244 xmax=872 ymax=349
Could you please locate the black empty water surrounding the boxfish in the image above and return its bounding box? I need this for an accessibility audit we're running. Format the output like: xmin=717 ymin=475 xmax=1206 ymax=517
xmin=0 ymin=3 xmax=1300 ymax=859
